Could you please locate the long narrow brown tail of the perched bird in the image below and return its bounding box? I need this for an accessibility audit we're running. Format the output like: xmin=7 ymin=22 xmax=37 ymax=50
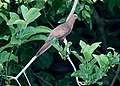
xmin=35 ymin=42 xmax=52 ymax=57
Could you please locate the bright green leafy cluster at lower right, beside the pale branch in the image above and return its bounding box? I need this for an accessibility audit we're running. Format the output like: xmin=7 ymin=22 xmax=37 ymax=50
xmin=72 ymin=41 xmax=120 ymax=85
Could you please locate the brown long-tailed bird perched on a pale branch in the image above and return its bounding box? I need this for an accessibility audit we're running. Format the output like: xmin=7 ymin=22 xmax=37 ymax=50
xmin=35 ymin=14 xmax=78 ymax=57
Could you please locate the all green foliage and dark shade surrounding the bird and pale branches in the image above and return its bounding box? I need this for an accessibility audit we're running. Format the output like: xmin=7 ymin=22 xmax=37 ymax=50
xmin=0 ymin=0 xmax=120 ymax=86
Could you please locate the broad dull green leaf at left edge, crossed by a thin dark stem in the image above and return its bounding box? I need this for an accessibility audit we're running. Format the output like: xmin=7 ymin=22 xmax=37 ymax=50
xmin=0 ymin=51 xmax=18 ymax=64
